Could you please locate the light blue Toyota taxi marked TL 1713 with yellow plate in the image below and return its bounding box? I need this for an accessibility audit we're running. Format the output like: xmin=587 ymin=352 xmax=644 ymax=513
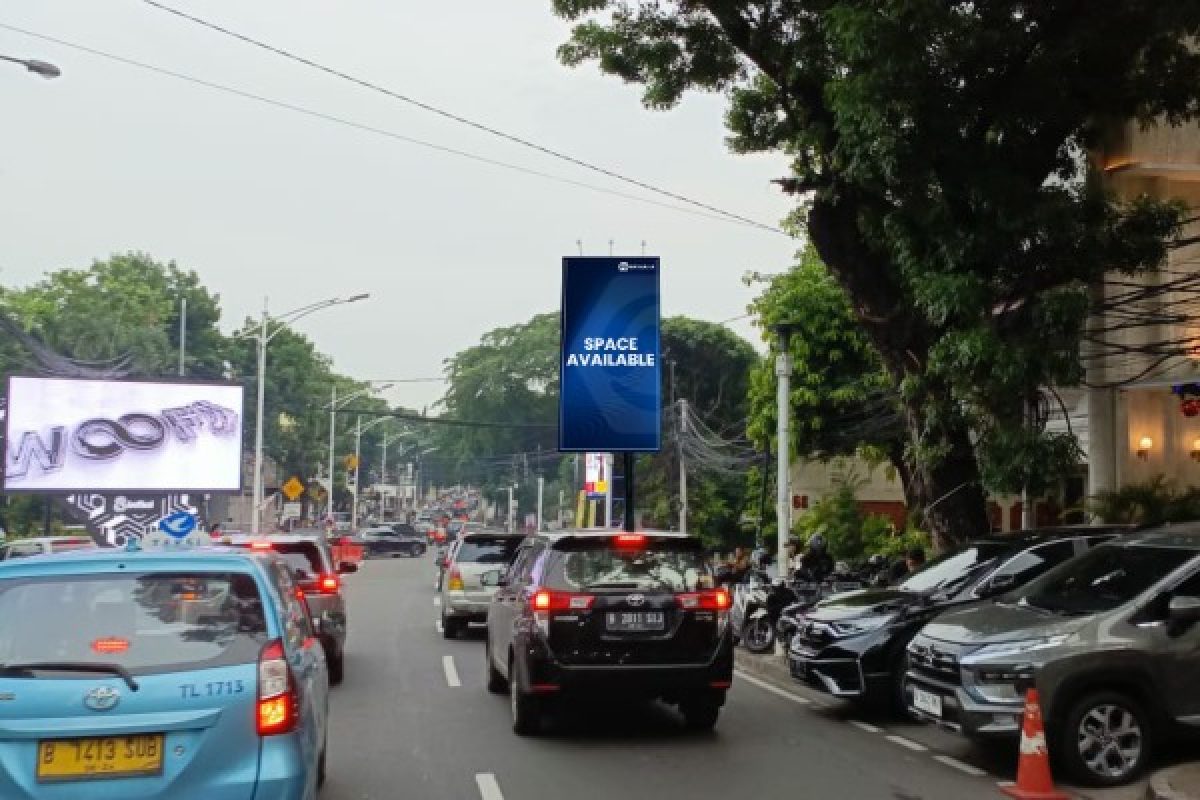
xmin=0 ymin=548 xmax=329 ymax=800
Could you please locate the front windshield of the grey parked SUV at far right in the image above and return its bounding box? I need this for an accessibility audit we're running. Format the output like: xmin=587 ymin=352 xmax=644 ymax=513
xmin=1022 ymin=545 xmax=1196 ymax=614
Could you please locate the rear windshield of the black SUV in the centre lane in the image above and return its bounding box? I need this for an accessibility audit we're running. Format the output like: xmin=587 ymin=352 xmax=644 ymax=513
xmin=545 ymin=542 xmax=715 ymax=591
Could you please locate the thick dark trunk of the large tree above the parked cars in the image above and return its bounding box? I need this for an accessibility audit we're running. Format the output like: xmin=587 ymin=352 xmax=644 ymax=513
xmin=809 ymin=192 xmax=991 ymax=549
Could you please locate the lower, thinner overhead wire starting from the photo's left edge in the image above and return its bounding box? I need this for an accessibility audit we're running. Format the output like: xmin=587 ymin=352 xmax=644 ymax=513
xmin=0 ymin=23 xmax=746 ymax=224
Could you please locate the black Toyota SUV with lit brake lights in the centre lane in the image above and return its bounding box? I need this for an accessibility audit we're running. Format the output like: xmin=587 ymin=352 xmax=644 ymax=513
xmin=482 ymin=531 xmax=733 ymax=735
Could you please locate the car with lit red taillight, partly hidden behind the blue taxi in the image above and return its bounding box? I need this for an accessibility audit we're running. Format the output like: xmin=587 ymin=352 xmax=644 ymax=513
xmin=222 ymin=530 xmax=359 ymax=685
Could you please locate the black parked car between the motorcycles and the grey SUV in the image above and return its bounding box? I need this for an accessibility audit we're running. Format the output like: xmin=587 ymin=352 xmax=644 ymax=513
xmin=787 ymin=527 xmax=1126 ymax=709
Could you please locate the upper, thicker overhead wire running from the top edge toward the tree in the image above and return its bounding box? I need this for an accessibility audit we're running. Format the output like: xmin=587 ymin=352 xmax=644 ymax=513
xmin=143 ymin=0 xmax=788 ymax=236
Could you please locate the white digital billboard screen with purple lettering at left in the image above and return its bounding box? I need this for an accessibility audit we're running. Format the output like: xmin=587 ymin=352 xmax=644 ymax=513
xmin=4 ymin=375 xmax=242 ymax=493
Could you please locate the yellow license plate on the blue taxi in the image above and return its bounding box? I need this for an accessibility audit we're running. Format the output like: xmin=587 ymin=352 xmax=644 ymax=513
xmin=37 ymin=733 xmax=164 ymax=781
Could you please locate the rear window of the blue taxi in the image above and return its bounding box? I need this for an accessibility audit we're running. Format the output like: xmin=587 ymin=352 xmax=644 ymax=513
xmin=0 ymin=572 xmax=268 ymax=674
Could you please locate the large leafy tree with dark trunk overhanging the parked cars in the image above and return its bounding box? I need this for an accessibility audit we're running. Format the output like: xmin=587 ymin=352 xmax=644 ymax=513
xmin=553 ymin=0 xmax=1200 ymax=545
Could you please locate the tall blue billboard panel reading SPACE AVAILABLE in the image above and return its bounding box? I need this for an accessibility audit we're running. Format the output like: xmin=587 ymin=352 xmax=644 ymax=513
xmin=558 ymin=255 xmax=662 ymax=452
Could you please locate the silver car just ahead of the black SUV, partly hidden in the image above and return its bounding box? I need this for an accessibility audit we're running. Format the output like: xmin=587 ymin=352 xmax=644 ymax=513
xmin=440 ymin=531 xmax=524 ymax=639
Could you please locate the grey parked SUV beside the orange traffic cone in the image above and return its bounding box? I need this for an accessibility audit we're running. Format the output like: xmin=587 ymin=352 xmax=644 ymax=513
xmin=908 ymin=523 xmax=1200 ymax=786
